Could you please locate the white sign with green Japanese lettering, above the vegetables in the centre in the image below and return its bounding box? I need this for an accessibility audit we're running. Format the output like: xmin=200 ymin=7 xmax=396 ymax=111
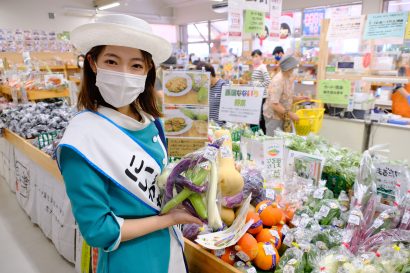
xmin=219 ymin=85 xmax=264 ymax=124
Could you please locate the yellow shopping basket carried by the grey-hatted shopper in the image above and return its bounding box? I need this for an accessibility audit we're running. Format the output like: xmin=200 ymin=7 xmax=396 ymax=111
xmin=293 ymin=100 xmax=325 ymax=136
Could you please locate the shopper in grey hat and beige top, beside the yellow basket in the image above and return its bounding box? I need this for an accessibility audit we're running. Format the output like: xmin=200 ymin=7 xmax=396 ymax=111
xmin=263 ymin=56 xmax=308 ymax=136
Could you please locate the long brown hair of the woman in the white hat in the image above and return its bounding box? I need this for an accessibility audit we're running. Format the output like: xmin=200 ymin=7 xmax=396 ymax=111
xmin=77 ymin=46 xmax=162 ymax=118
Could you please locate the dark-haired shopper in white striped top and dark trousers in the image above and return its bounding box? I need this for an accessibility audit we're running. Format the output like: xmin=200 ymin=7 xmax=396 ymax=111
xmin=252 ymin=49 xmax=271 ymax=133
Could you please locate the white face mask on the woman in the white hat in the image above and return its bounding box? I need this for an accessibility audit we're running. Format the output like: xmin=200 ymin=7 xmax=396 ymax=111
xmin=95 ymin=67 xmax=147 ymax=108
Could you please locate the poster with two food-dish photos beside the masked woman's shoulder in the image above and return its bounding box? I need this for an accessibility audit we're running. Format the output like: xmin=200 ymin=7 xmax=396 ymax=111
xmin=163 ymin=70 xmax=210 ymax=158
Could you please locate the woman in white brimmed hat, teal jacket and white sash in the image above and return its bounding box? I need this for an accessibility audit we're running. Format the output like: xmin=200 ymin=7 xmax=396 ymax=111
xmin=57 ymin=15 xmax=200 ymax=273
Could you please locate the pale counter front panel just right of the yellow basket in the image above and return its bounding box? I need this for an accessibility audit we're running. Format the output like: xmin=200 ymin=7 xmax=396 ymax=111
xmin=319 ymin=116 xmax=367 ymax=152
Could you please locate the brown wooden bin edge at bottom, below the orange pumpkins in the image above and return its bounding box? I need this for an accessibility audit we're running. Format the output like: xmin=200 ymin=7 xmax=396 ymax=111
xmin=185 ymin=239 xmax=241 ymax=273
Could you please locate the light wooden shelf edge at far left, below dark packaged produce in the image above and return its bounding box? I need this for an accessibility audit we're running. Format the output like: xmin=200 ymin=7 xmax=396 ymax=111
xmin=4 ymin=129 xmax=63 ymax=183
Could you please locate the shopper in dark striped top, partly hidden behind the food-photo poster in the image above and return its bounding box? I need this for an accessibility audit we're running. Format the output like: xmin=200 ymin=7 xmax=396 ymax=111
xmin=196 ymin=62 xmax=226 ymax=126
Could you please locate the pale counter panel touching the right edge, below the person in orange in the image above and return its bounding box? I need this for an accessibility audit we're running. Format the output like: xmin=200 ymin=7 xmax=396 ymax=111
xmin=369 ymin=123 xmax=410 ymax=162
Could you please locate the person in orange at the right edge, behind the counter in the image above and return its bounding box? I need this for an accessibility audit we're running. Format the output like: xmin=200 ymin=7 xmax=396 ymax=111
xmin=391 ymin=58 xmax=410 ymax=118
